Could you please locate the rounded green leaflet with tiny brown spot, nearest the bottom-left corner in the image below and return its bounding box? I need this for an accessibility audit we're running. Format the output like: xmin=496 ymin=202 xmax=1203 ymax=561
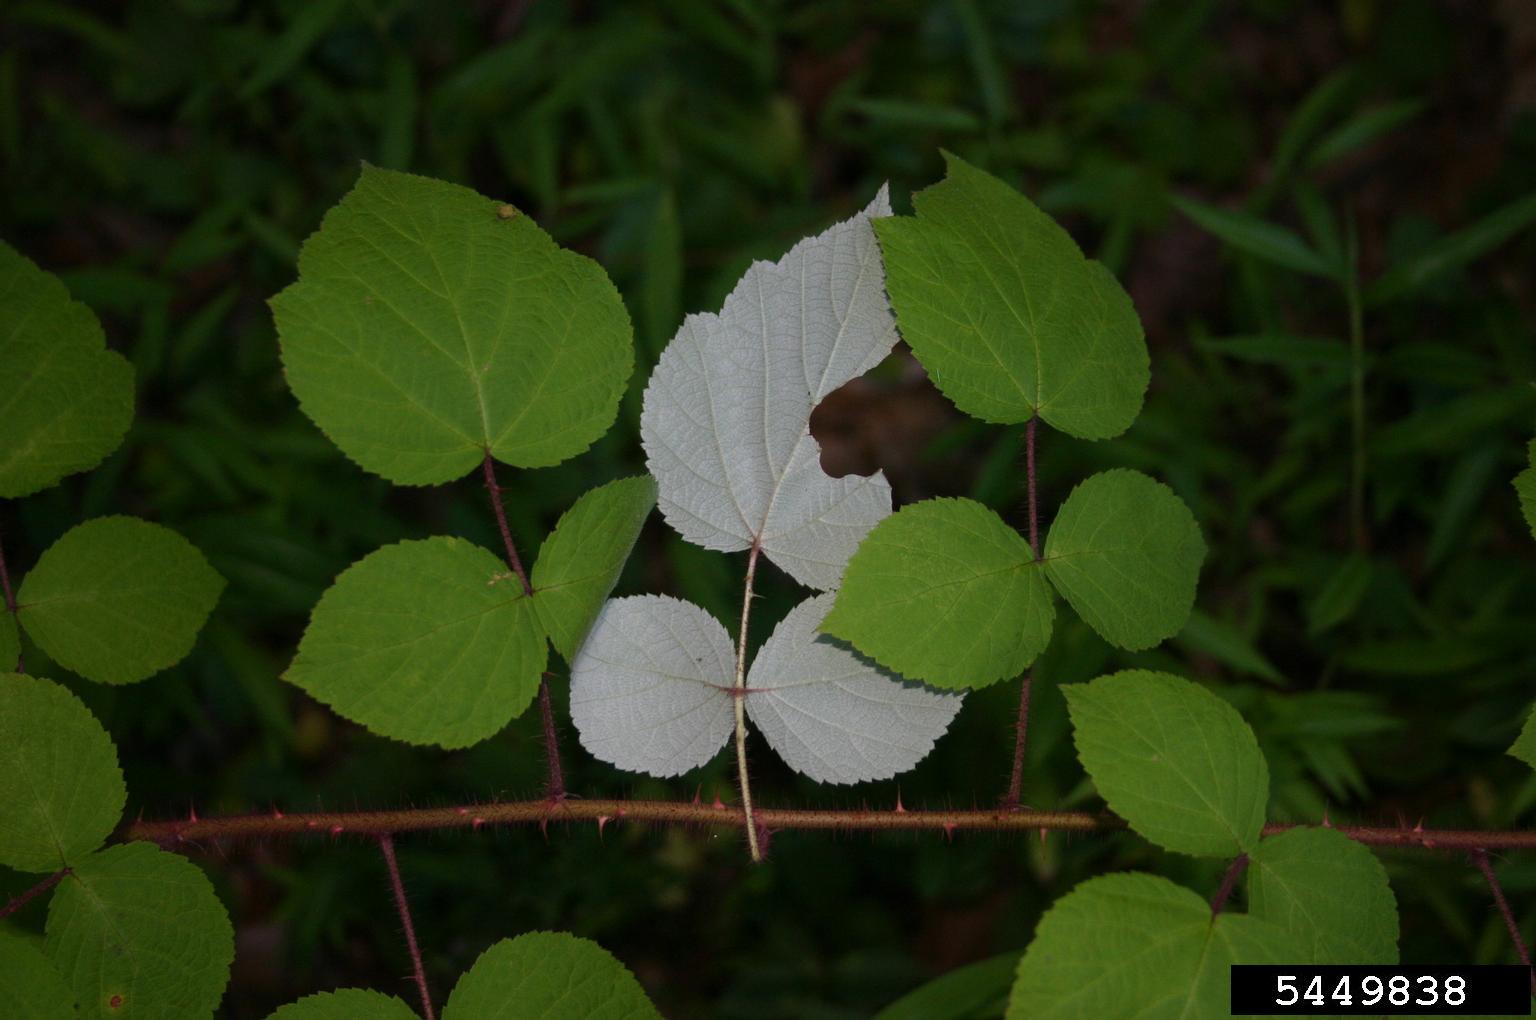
xmin=43 ymin=843 xmax=235 ymax=1020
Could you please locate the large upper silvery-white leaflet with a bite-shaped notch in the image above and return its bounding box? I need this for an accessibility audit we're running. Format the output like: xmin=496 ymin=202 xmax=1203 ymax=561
xmin=641 ymin=189 xmax=895 ymax=590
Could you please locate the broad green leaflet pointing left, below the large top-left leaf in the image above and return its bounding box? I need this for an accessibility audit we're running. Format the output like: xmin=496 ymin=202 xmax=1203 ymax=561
xmin=284 ymin=538 xmax=547 ymax=748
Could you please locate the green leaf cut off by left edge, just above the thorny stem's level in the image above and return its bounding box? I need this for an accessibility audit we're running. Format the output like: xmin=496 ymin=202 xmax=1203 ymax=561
xmin=0 ymin=673 xmax=127 ymax=871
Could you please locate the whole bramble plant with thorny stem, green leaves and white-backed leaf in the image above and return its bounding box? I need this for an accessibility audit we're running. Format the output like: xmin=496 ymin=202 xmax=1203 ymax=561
xmin=0 ymin=155 xmax=1536 ymax=1020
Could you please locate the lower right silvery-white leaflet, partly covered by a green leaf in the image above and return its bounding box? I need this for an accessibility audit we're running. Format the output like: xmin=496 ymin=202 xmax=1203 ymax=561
xmin=746 ymin=594 xmax=962 ymax=783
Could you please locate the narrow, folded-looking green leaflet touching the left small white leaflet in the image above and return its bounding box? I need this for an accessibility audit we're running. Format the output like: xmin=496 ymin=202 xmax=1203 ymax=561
xmin=530 ymin=475 xmax=656 ymax=662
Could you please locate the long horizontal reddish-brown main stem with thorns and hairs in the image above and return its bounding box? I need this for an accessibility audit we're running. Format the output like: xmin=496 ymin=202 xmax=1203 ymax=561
xmin=123 ymin=799 xmax=1536 ymax=851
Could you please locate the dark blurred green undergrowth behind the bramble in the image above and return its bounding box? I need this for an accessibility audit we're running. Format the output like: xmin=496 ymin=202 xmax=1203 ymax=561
xmin=0 ymin=0 xmax=1536 ymax=1020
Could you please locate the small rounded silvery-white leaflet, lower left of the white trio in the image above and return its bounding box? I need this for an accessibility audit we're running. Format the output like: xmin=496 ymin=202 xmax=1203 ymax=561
xmin=571 ymin=594 xmax=736 ymax=776
